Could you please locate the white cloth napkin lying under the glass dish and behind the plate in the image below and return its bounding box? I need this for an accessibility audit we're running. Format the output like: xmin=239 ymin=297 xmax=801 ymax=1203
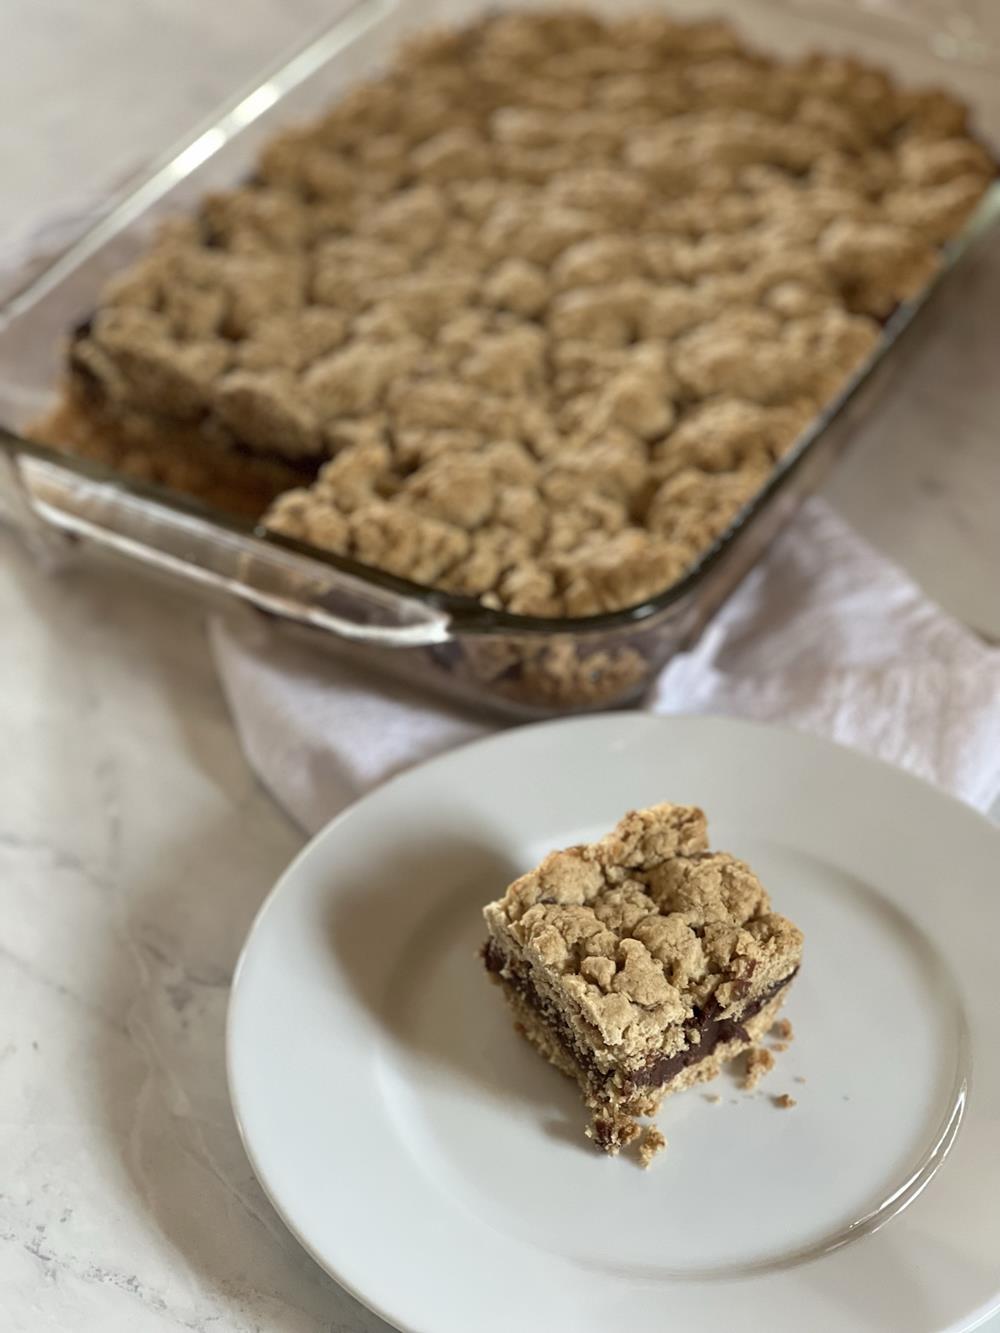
xmin=211 ymin=500 xmax=1000 ymax=832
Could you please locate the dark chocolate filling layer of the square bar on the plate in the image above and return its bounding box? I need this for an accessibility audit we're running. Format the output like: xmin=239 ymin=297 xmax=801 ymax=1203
xmin=483 ymin=940 xmax=799 ymax=1096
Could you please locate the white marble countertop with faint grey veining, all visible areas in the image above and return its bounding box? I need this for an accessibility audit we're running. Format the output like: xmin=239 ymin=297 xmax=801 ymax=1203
xmin=0 ymin=0 xmax=1000 ymax=1333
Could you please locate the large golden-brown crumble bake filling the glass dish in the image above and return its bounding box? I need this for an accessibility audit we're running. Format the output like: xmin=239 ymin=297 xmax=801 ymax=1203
xmin=44 ymin=11 xmax=995 ymax=618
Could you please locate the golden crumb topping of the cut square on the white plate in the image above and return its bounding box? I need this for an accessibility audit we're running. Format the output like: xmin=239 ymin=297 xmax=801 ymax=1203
xmin=485 ymin=804 xmax=801 ymax=1058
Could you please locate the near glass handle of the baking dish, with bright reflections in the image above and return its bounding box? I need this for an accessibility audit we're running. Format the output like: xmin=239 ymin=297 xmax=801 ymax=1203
xmin=0 ymin=447 xmax=451 ymax=648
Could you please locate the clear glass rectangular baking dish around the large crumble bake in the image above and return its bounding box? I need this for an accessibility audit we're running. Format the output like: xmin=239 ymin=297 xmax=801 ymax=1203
xmin=0 ymin=0 xmax=1000 ymax=717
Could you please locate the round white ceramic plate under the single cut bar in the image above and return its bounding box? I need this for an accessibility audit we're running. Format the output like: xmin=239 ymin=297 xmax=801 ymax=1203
xmin=228 ymin=713 xmax=1000 ymax=1333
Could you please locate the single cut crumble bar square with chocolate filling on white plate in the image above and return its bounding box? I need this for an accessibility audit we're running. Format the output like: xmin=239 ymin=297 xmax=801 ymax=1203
xmin=484 ymin=804 xmax=803 ymax=1153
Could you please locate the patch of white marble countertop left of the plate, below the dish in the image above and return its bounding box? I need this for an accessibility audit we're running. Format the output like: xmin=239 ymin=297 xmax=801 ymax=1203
xmin=0 ymin=533 xmax=394 ymax=1333
